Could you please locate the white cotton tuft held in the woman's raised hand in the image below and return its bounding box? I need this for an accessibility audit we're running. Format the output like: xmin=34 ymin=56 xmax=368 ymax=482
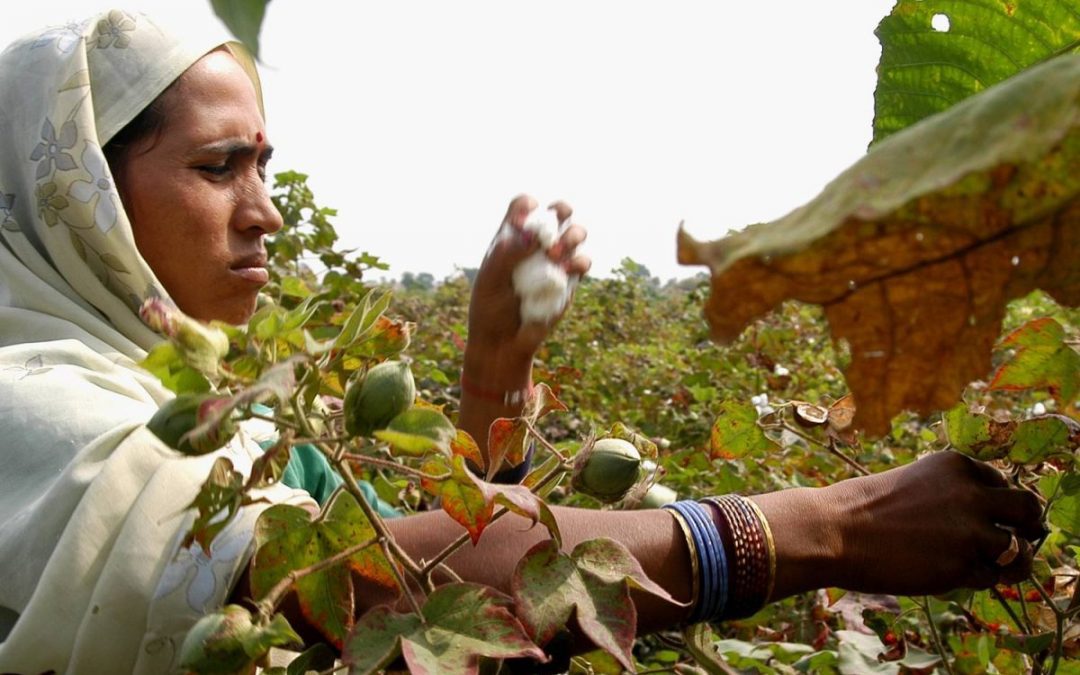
xmin=502 ymin=203 xmax=572 ymax=323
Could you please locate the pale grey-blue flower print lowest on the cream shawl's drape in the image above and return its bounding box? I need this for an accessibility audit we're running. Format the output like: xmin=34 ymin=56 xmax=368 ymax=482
xmin=153 ymin=519 xmax=252 ymax=612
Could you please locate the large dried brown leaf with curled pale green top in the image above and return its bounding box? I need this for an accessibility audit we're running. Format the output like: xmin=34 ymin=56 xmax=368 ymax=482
xmin=678 ymin=55 xmax=1080 ymax=434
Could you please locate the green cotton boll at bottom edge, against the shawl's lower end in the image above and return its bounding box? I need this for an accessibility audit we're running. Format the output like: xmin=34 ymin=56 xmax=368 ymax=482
xmin=179 ymin=605 xmax=301 ymax=675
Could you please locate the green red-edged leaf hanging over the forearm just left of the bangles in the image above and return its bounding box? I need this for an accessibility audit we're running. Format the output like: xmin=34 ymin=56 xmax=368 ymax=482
xmin=512 ymin=539 xmax=675 ymax=671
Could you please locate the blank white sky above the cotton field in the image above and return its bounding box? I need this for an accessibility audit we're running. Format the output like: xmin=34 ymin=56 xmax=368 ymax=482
xmin=0 ymin=0 xmax=892 ymax=280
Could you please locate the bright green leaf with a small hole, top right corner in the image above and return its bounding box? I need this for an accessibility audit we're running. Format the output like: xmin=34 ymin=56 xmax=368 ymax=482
xmin=874 ymin=0 xmax=1080 ymax=143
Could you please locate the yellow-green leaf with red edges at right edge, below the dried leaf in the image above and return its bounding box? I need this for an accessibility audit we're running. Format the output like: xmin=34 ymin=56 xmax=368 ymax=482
xmin=990 ymin=318 xmax=1080 ymax=408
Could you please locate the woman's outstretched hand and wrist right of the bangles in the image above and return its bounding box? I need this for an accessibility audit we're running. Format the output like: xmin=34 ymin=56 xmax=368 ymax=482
xmin=754 ymin=451 xmax=1044 ymax=597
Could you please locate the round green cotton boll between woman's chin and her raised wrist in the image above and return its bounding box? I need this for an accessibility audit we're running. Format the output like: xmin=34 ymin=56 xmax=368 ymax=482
xmin=345 ymin=361 xmax=416 ymax=436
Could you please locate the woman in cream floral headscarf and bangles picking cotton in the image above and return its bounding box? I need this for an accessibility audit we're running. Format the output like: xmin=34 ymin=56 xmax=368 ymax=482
xmin=0 ymin=11 xmax=1041 ymax=673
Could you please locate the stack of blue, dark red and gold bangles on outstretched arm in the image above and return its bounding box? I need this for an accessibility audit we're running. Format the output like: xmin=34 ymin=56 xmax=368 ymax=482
xmin=664 ymin=495 xmax=777 ymax=623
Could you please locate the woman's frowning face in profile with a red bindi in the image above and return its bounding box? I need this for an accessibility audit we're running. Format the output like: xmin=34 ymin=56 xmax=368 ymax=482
xmin=118 ymin=51 xmax=282 ymax=323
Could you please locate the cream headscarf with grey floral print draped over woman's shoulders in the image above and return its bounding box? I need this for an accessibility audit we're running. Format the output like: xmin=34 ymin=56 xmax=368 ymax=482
xmin=0 ymin=10 xmax=306 ymax=673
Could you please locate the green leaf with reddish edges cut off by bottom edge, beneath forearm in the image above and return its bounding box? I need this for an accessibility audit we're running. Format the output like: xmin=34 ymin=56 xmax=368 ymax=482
xmin=341 ymin=583 xmax=546 ymax=675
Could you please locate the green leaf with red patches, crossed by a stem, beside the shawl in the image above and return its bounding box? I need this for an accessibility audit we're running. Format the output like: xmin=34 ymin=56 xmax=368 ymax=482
xmin=251 ymin=490 xmax=396 ymax=648
